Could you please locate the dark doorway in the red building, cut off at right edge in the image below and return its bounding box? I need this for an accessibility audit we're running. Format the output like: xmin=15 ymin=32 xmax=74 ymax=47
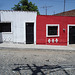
xmin=69 ymin=26 xmax=75 ymax=44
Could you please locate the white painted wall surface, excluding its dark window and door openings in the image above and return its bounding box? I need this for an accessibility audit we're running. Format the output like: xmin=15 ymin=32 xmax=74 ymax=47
xmin=0 ymin=11 xmax=37 ymax=44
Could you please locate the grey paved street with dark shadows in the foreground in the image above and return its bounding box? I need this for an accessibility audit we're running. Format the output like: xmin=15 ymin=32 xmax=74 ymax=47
xmin=0 ymin=49 xmax=75 ymax=75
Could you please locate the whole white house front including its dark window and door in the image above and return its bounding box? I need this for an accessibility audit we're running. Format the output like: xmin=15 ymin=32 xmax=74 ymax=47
xmin=0 ymin=11 xmax=37 ymax=44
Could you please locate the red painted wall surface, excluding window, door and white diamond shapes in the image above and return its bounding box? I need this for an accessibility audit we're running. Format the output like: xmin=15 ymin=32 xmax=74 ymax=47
xmin=36 ymin=15 xmax=75 ymax=45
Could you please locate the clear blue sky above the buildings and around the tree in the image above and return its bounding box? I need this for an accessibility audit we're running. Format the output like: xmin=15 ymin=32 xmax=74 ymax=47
xmin=0 ymin=0 xmax=75 ymax=15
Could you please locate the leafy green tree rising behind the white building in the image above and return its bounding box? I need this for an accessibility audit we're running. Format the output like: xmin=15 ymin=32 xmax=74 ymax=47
xmin=12 ymin=0 xmax=40 ymax=15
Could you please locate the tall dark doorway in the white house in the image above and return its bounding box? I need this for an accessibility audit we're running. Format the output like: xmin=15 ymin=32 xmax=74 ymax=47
xmin=26 ymin=23 xmax=34 ymax=44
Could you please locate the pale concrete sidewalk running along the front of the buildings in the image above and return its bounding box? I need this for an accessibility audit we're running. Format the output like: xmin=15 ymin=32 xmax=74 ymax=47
xmin=0 ymin=43 xmax=75 ymax=50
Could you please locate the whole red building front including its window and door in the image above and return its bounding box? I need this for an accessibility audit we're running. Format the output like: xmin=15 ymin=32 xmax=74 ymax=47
xmin=36 ymin=15 xmax=75 ymax=45
